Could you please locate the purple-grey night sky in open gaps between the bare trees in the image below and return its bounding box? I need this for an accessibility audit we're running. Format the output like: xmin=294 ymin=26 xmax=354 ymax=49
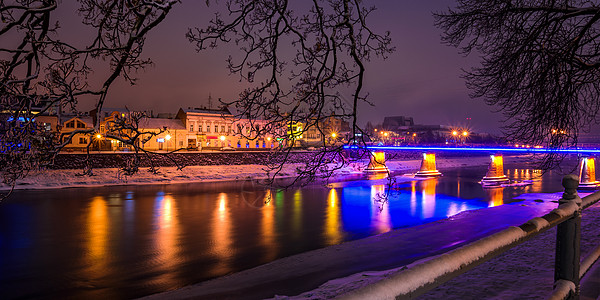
xmin=57 ymin=0 xmax=502 ymax=133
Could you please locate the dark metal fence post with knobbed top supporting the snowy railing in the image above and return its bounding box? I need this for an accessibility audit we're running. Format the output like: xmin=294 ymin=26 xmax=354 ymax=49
xmin=554 ymin=175 xmax=581 ymax=299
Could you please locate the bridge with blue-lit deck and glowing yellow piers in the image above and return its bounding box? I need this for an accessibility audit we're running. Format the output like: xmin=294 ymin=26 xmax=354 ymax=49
xmin=344 ymin=146 xmax=600 ymax=188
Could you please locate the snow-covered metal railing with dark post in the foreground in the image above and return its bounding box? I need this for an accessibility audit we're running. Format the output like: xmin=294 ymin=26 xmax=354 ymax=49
xmin=341 ymin=175 xmax=600 ymax=299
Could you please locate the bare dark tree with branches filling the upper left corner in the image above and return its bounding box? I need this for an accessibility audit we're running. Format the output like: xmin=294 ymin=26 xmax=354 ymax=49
xmin=0 ymin=0 xmax=178 ymax=198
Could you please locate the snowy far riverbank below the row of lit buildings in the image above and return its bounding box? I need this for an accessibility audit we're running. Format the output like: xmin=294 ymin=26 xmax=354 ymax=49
xmin=0 ymin=155 xmax=516 ymax=190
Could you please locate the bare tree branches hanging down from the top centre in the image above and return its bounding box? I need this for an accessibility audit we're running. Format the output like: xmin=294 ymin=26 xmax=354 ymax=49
xmin=187 ymin=0 xmax=393 ymax=185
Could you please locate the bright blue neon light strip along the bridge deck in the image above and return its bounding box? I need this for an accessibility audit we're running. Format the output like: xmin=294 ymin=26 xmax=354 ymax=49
xmin=344 ymin=145 xmax=600 ymax=154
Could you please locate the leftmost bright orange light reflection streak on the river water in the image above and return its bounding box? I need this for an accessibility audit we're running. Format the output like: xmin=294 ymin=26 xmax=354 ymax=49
xmin=86 ymin=196 xmax=109 ymax=278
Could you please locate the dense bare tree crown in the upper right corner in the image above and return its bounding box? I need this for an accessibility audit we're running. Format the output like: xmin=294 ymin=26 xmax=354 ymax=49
xmin=434 ymin=0 xmax=600 ymax=168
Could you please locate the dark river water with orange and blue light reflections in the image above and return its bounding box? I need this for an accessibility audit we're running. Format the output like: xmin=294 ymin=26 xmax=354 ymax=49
xmin=0 ymin=167 xmax=562 ymax=299
